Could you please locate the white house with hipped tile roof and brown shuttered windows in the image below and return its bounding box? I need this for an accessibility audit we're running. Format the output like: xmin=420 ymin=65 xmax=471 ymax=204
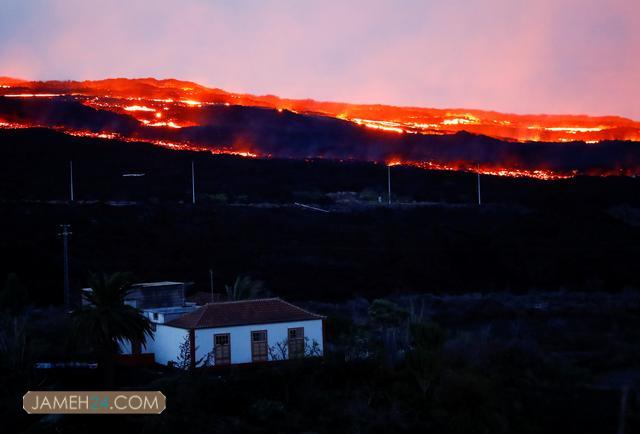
xmin=133 ymin=298 xmax=324 ymax=367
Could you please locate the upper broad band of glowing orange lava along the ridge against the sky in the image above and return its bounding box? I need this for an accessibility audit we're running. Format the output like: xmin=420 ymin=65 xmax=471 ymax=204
xmin=5 ymin=78 xmax=640 ymax=143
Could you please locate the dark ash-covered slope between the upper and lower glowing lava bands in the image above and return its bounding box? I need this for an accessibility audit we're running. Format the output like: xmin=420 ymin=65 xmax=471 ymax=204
xmin=0 ymin=96 xmax=640 ymax=174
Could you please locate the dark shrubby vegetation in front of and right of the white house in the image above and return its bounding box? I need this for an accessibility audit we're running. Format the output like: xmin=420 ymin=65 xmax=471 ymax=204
xmin=0 ymin=284 xmax=640 ymax=434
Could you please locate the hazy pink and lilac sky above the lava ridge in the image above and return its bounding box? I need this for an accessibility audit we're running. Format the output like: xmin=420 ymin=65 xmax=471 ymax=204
xmin=0 ymin=0 xmax=640 ymax=120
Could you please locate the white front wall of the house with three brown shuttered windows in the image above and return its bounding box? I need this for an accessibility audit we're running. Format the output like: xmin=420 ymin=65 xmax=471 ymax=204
xmin=192 ymin=319 xmax=323 ymax=364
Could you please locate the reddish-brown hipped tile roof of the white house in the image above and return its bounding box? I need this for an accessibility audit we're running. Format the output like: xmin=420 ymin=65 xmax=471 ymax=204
xmin=167 ymin=298 xmax=324 ymax=329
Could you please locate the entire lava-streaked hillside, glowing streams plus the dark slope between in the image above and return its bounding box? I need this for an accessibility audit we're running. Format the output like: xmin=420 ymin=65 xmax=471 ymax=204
xmin=0 ymin=78 xmax=640 ymax=179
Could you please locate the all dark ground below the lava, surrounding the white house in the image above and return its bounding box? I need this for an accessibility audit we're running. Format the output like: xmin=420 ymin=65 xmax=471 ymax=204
xmin=0 ymin=130 xmax=640 ymax=434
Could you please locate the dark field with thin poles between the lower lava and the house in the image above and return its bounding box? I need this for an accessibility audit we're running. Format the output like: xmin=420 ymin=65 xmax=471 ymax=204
xmin=0 ymin=130 xmax=640 ymax=304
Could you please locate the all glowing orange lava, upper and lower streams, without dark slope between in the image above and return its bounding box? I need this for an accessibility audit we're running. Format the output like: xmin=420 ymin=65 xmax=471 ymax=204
xmin=0 ymin=78 xmax=640 ymax=179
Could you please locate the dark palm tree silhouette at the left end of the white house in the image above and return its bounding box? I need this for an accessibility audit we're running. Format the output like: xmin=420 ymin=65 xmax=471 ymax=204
xmin=72 ymin=273 xmax=152 ymax=386
